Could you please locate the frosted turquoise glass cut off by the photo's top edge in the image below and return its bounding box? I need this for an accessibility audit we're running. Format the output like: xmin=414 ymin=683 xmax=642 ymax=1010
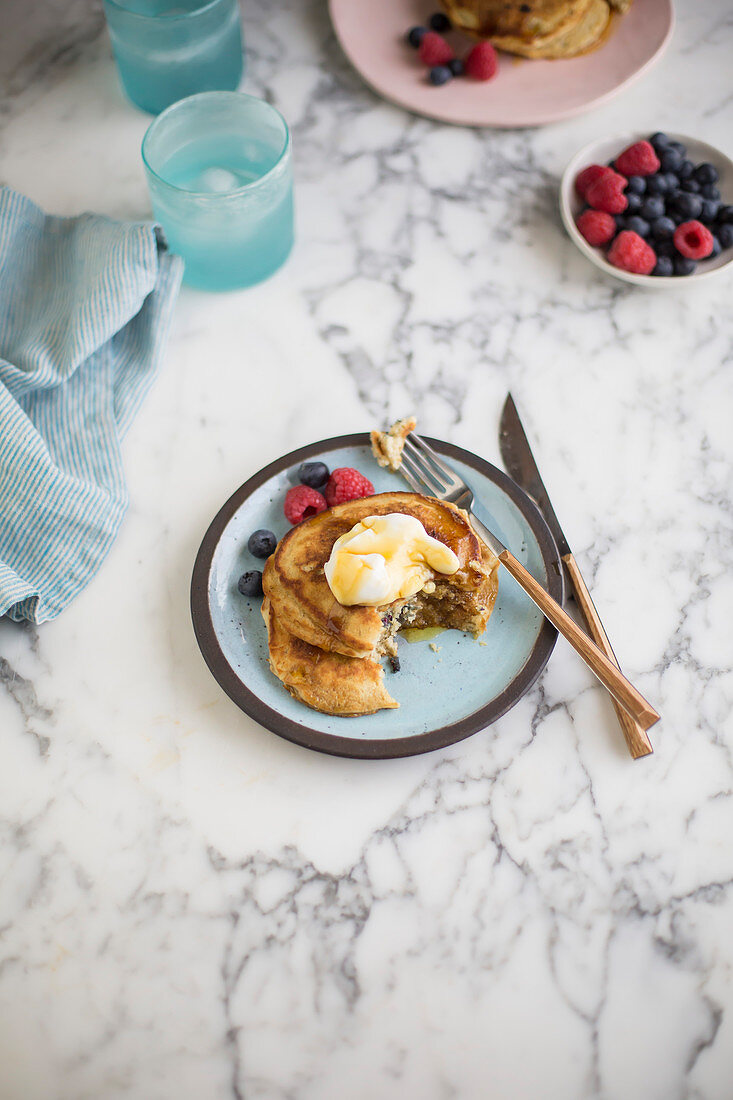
xmin=103 ymin=0 xmax=244 ymax=114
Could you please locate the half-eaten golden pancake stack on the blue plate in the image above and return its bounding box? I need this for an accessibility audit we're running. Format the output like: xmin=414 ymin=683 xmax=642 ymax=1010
xmin=262 ymin=493 xmax=499 ymax=716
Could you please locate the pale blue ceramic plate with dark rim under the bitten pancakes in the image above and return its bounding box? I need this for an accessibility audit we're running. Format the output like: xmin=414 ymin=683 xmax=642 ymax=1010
xmin=192 ymin=435 xmax=562 ymax=758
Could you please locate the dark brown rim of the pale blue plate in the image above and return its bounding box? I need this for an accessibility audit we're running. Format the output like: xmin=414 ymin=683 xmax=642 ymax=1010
xmin=190 ymin=432 xmax=564 ymax=760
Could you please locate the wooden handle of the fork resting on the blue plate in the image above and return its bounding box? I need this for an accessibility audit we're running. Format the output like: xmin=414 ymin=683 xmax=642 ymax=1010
xmin=499 ymin=550 xmax=659 ymax=729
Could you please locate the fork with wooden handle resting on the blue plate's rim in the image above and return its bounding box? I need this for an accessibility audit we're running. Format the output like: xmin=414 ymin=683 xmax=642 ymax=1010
xmin=400 ymin=431 xmax=659 ymax=729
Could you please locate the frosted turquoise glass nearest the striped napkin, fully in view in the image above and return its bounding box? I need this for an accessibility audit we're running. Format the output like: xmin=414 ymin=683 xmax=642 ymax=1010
xmin=142 ymin=91 xmax=293 ymax=290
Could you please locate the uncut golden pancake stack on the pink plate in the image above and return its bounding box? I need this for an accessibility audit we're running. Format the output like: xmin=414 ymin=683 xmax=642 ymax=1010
xmin=435 ymin=0 xmax=632 ymax=59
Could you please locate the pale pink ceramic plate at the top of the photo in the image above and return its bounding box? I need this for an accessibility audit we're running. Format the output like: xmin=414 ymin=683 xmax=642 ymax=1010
xmin=329 ymin=0 xmax=675 ymax=128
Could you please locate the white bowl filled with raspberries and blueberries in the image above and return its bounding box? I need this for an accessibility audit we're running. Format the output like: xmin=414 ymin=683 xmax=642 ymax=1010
xmin=560 ymin=132 xmax=733 ymax=289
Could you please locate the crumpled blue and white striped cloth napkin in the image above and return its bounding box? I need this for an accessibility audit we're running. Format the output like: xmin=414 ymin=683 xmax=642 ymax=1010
xmin=0 ymin=188 xmax=183 ymax=623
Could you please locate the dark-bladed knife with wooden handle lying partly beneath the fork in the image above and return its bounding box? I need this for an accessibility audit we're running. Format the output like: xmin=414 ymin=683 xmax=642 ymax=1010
xmin=499 ymin=394 xmax=654 ymax=760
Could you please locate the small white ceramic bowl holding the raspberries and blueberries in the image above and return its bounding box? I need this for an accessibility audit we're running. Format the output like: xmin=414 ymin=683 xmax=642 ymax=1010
xmin=560 ymin=130 xmax=733 ymax=290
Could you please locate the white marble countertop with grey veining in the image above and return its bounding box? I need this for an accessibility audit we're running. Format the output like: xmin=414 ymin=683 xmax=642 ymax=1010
xmin=0 ymin=0 xmax=733 ymax=1100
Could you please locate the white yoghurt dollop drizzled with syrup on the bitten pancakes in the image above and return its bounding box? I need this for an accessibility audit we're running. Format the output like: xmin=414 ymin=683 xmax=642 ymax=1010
xmin=324 ymin=512 xmax=460 ymax=607
